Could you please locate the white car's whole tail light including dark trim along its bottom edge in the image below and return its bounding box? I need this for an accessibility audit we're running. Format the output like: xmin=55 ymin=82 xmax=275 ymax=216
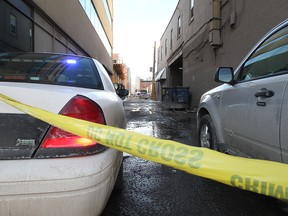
xmin=36 ymin=95 xmax=106 ymax=157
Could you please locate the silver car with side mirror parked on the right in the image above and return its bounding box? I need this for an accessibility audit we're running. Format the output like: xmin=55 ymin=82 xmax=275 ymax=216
xmin=197 ymin=20 xmax=288 ymax=163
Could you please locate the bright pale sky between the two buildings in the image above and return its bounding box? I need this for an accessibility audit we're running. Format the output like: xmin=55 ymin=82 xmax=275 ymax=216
xmin=113 ymin=0 xmax=178 ymax=82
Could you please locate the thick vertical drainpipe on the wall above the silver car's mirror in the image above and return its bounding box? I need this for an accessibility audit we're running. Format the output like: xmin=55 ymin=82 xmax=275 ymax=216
xmin=209 ymin=0 xmax=221 ymax=47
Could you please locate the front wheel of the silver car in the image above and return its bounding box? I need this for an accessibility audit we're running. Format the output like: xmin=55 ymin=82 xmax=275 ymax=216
xmin=198 ymin=114 xmax=218 ymax=150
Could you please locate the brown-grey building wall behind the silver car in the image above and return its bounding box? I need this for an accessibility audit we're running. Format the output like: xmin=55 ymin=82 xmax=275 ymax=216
xmin=155 ymin=0 xmax=288 ymax=110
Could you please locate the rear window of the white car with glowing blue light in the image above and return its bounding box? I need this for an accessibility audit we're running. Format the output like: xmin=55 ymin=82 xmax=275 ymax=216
xmin=0 ymin=53 xmax=103 ymax=89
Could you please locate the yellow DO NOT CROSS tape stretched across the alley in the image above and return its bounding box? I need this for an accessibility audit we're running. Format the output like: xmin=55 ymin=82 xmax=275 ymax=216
xmin=0 ymin=94 xmax=288 ymax=201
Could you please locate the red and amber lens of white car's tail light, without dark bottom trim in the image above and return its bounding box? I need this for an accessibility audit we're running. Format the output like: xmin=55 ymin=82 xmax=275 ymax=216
xmin=41 ymin=95 xmax=105 ymax=148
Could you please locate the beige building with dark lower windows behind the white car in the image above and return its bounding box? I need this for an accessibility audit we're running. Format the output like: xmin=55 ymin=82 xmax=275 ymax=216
xmin=0 ymin=0 xmax=114 ymax=76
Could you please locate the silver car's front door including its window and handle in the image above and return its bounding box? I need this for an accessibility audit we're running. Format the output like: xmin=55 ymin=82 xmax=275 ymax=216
xmin=221 ymin=24 xmax=288 ymax=161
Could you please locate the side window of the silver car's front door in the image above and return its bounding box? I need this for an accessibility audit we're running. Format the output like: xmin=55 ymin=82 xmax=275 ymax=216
xmin=238 ymin=24 xmax=288 ymax=81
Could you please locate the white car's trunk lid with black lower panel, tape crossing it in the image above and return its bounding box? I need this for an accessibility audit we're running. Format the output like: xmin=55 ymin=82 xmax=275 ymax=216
xmin=0 ymin=82 xmax=94 ymax=160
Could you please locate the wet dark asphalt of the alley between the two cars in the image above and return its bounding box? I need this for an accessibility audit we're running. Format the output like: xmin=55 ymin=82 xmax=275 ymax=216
xmin=102 ymin=99 xmax=288 ymax=216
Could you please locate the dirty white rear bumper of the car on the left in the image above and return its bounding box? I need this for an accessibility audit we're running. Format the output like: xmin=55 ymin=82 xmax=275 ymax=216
xmin=0 ymin=149 xmax=122 ymax=216
